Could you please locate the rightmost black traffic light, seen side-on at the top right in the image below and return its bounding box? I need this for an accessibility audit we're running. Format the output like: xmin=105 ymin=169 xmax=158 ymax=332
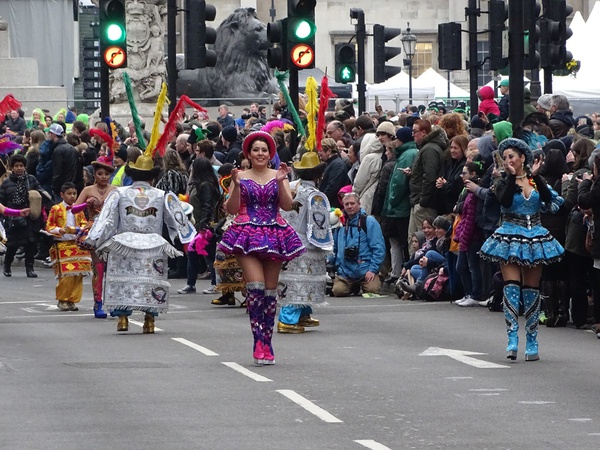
xmin=540 ymin=0 xmax=573 ymax=69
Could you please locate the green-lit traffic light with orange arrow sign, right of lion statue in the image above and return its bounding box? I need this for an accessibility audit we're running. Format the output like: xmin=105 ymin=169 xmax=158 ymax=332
xmin=287 ymin=0 xmax=317 ymax=69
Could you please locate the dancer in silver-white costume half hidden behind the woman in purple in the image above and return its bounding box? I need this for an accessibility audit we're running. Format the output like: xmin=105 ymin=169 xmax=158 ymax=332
xmin=277 ymin=151 xmax=333 ymax=334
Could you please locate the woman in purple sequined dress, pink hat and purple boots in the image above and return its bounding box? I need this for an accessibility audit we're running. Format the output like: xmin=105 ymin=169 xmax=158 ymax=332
xmin=219 ymin=131 xmax=306 ymax=365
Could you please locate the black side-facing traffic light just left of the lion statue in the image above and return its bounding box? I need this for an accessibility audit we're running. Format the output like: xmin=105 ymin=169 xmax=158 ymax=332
xmin=185 ymin=0 xmax=217 ymax=69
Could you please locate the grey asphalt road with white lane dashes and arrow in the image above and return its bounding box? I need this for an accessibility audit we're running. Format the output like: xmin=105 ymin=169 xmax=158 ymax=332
xmin=0 ymin=267 xmax=600 ymax=450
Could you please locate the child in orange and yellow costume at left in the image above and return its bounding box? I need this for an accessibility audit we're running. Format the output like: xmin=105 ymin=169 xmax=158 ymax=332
xmin=46 ymin=183 xmax=92 ymax=311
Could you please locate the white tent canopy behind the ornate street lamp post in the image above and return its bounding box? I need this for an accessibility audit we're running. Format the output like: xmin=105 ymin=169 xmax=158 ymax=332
xmin=367 ymin=72 xmax=435 ymax=111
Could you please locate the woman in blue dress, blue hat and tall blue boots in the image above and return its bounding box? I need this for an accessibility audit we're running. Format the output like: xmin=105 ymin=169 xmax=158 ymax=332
xmin=480 ymin=138 xmax=564 ymax=361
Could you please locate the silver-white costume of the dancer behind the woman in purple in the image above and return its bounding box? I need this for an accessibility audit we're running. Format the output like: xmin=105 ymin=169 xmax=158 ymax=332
xmin=279 ymin=180 xmax=333 ymax=306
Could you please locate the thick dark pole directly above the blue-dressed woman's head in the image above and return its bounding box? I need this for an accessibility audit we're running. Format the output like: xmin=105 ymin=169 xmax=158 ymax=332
xmin=508 ymin=0 xmax=525 ymax=129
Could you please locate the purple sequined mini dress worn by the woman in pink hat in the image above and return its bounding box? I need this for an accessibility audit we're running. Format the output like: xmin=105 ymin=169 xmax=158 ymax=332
xmin=219 ymin=178 xmax=306 ymax=262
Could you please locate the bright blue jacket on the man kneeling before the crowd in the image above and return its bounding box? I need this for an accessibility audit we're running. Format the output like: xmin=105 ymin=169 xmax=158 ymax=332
xmin=333 ymin=209 xmax=385 ymax=280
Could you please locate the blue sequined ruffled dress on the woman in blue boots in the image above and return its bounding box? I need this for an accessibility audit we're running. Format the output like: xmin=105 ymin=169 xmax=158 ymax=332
xmin=479 ymin=189 xmax=564 ymax=267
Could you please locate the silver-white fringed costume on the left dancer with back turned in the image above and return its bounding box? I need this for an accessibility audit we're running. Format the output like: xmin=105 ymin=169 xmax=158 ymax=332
xmin=85 ymin=181 xmax=196 ymax=313
